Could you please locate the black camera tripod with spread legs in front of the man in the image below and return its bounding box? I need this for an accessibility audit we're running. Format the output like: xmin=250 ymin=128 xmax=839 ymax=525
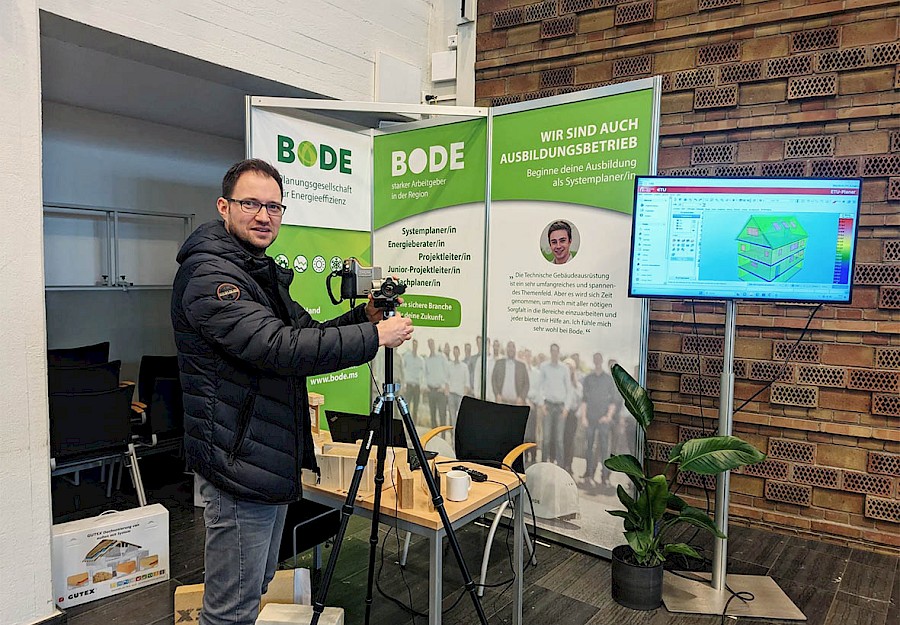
xmin=310 ymin=310 xmax=487 ymax=625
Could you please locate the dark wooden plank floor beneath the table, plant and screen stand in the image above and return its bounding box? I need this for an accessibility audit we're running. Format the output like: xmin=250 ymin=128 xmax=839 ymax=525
xmin=53 ymin=457 xmax=900 ymax=625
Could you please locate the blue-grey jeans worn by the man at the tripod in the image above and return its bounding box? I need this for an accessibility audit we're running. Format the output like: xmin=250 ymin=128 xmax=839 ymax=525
xmin=198 ymin=475 xmax=287 ymax=625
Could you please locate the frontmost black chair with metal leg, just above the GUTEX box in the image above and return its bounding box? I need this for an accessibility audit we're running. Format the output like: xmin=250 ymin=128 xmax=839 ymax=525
xmin=50 ymin=385 xmax=147 ymax=506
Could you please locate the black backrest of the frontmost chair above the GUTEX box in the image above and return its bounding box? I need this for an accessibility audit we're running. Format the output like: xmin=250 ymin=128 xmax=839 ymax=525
xmin=50 ymin=386 xmax=134 ymax=462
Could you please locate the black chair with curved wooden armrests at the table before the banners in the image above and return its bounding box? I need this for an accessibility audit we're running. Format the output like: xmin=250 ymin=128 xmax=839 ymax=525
xmin=400 ymin=395 xmax=537 ymax=596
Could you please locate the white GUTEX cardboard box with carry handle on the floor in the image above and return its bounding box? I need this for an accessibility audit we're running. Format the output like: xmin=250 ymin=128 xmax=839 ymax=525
xmin=52 ymin=503 xmax=169 ymax=608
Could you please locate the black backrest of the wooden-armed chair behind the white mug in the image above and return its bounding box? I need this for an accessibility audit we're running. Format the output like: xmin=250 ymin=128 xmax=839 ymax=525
xmin=455 ymin=396 xmax=531 ymax=473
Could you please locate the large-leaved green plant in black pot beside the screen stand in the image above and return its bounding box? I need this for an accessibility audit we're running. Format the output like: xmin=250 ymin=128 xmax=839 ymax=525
xmin=604 ymin=365 xmax=765 ymax=610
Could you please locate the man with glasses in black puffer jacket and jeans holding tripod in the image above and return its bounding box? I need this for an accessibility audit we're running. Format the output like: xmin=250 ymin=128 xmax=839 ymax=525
xmin=172 ymin=159 xmax=412 ymax=625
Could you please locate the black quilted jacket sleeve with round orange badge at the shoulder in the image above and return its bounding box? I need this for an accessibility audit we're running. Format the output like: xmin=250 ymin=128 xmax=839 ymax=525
xmin=182 ymin=263 xmax=378 ymax=376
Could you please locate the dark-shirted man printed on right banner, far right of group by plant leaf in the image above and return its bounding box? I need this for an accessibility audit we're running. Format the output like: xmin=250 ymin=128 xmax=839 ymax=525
xmin=581 ymin=353 xmax=618 ymax=488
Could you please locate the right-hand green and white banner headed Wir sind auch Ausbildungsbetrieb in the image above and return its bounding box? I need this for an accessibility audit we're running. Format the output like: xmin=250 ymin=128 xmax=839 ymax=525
xmin=486 ymin=86 xmax=657 ymax=548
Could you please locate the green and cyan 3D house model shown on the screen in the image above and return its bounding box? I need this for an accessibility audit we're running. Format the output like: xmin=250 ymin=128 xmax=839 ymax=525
xmin=737 ymin=215 xmax=809 ymax=282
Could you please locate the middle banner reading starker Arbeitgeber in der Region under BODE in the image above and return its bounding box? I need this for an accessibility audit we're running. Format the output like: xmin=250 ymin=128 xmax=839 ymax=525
xmin=373 ymin=119 xmax=487 ymax=426
